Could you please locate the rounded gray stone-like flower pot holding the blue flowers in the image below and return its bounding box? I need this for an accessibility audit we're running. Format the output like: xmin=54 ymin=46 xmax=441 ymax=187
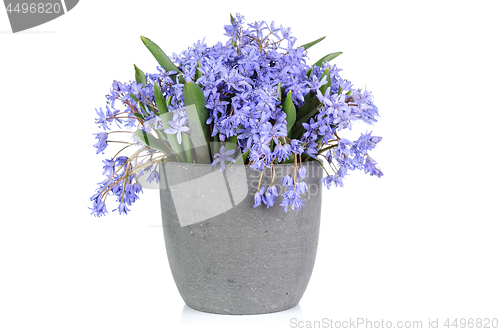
xmin=160 ymin=162 xmax=323 ymax=315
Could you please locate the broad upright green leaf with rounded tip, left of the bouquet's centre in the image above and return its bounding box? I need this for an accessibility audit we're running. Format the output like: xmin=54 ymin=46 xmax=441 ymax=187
xmin=183 ymin=82 xmax=211 ymax=164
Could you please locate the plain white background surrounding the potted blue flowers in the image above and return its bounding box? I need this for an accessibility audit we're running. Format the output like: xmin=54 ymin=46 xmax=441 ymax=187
xmin=0 ymin=0 xmax=500 ymax=332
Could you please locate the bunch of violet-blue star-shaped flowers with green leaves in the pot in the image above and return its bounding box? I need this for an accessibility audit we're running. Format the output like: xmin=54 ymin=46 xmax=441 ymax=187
xmin=91 ymin=14 xmax=382 ymax=216
